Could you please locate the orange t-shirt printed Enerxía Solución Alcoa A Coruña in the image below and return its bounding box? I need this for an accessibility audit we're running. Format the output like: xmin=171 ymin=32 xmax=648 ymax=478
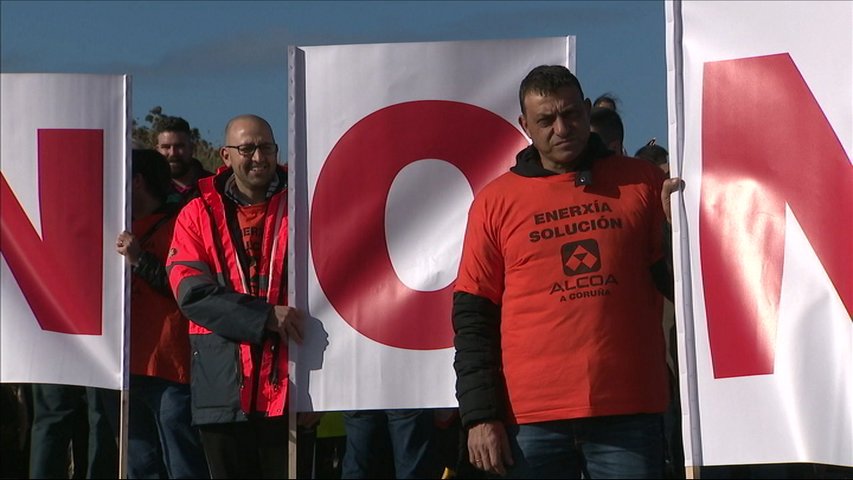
xmin=455 ymin=156 xmax=668 ymax=424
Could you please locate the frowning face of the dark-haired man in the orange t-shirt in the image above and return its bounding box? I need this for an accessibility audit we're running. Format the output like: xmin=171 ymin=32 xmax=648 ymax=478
xmin=518 ymin=86 xmax=591 ymax=173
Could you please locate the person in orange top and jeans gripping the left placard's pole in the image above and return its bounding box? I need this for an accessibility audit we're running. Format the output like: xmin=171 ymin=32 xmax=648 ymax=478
xmin=116 ymin=149 xmax=210 ymax=478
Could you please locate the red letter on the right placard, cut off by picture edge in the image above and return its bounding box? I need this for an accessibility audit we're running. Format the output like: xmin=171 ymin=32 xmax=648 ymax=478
xmin=699 ymin=54 xmax=853 ymax=378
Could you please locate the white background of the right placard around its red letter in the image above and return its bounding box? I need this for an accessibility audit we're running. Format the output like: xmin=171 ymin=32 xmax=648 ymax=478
xmin=666 ymin=2 xmax=853 ymax=466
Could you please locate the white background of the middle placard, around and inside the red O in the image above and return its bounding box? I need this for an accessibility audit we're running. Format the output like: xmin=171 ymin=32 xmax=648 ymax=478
xmin=289 ymin=37 xmax=575 ymax=411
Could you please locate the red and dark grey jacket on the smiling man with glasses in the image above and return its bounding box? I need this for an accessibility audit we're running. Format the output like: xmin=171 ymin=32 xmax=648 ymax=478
xmin=167 ymin=167 xmax=288 ymax=425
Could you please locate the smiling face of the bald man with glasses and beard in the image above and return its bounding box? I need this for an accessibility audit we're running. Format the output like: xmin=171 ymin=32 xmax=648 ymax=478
xmin=219 ymin=117 xmax=278 ymax=198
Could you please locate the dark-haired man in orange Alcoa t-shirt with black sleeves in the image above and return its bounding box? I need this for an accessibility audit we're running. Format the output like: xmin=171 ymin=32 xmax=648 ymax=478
xmin=453 ymin=66 xmax=672 ymax=478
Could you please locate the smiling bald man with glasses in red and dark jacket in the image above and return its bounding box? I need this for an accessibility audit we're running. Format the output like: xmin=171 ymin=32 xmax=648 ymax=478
xmin=167 ymin=115 xmax=312 ymax=478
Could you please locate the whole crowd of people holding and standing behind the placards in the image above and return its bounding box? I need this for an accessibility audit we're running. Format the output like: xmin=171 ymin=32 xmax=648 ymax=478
xmin=3 ymin=65 xmax=844 ymax=478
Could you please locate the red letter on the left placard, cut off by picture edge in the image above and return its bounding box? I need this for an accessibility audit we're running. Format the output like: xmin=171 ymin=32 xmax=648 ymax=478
xmin=0 ymin=129 xmax=104 ymax=335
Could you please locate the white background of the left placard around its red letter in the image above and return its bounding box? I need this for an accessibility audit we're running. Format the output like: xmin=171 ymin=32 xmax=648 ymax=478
xmin=0 ymin=74 xmax=130 ymax=389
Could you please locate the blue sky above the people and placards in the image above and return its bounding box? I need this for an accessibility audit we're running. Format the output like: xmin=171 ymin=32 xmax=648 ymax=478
xmin=0 ymin=0 xmax=667 ymax=153
